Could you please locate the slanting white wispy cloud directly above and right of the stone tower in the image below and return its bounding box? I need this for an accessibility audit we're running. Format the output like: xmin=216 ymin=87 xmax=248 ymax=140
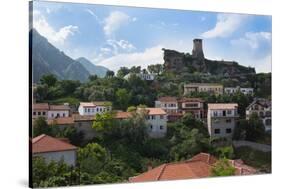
xmin=201 ymin=14 xmax=247 ymax=38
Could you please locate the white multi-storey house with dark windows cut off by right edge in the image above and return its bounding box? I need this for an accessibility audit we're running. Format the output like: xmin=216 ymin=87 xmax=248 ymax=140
xmin=246 ymin=98 xmax=271 ymax=131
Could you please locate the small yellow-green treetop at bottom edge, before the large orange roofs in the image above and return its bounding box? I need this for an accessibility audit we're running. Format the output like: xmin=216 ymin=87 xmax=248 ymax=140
xmin=211 ymin=158 xmax=235 ymax=176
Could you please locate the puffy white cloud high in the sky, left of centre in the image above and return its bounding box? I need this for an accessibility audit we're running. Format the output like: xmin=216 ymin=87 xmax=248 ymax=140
xmin=103 ymin=11 xmax=133 ymax=36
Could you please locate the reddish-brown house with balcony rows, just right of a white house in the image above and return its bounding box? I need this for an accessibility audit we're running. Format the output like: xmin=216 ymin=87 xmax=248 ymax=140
xmin=178 ymin=98 xmax=205 ymax=120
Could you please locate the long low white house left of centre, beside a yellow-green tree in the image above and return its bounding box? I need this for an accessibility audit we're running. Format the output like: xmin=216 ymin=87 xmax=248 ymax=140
xmin=78 ymin=101 xmax=112 ymax=116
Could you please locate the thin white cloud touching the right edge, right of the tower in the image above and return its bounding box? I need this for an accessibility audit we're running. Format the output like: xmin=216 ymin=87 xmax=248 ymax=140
xmin=230 ymin=32 xmax=271 ymax=49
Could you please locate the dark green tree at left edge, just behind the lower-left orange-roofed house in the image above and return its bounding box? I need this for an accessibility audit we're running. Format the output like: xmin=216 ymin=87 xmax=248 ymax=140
xmin=33 ymin=117 xmax=52 ymax=137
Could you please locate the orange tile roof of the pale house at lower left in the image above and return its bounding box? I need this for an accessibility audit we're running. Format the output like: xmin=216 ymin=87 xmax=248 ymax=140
xmin=32 ymin=134 xmax=77 ymax=154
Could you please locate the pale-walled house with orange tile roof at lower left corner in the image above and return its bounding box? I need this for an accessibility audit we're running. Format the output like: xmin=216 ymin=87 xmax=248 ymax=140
xmin=32 ymin=134 xmax=78 ymax=166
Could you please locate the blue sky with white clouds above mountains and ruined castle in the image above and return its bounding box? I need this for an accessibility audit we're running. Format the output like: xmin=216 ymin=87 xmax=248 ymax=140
xmin=32 ymin=1 xmax=272 ymax=73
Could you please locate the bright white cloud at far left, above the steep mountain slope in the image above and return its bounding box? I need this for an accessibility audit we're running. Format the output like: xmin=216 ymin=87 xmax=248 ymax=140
xmin=33 ymin=11 xmax=78 ymax=45
